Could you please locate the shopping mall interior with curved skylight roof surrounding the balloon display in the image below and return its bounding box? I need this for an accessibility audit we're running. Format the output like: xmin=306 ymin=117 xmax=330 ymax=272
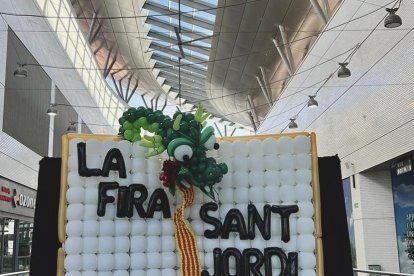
xmin=0 ymin=0 xmax=414 ymax=276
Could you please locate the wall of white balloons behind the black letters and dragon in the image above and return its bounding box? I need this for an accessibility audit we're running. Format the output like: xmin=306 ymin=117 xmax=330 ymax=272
xmin=64 ymin=136 xmax=316 ymax=276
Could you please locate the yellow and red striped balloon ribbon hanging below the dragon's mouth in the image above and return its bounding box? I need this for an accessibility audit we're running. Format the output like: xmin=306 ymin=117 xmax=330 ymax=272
xmin=173 ymin=185 xmax=201 ymax=276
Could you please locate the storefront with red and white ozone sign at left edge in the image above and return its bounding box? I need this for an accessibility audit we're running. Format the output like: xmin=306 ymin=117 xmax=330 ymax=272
xmin=0 ymin=177 xmax=36 ymax=274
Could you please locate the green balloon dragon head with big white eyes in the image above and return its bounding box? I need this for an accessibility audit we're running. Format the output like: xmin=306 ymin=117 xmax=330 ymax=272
xmin=119 ymin=105 xmax=228 ymax=200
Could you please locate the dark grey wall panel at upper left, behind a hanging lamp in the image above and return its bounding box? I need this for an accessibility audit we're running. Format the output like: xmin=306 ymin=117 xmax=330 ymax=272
xmin=3 ymin=28 xmax=51 ymax=156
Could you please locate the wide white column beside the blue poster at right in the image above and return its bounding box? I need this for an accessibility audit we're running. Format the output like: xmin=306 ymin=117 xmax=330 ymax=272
xmin=352 ymin=170 xmax=399 ymax=276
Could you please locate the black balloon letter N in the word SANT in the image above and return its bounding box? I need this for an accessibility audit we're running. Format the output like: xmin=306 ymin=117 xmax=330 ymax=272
xmin=247 ymin=204 xmax=271 ymax=240
